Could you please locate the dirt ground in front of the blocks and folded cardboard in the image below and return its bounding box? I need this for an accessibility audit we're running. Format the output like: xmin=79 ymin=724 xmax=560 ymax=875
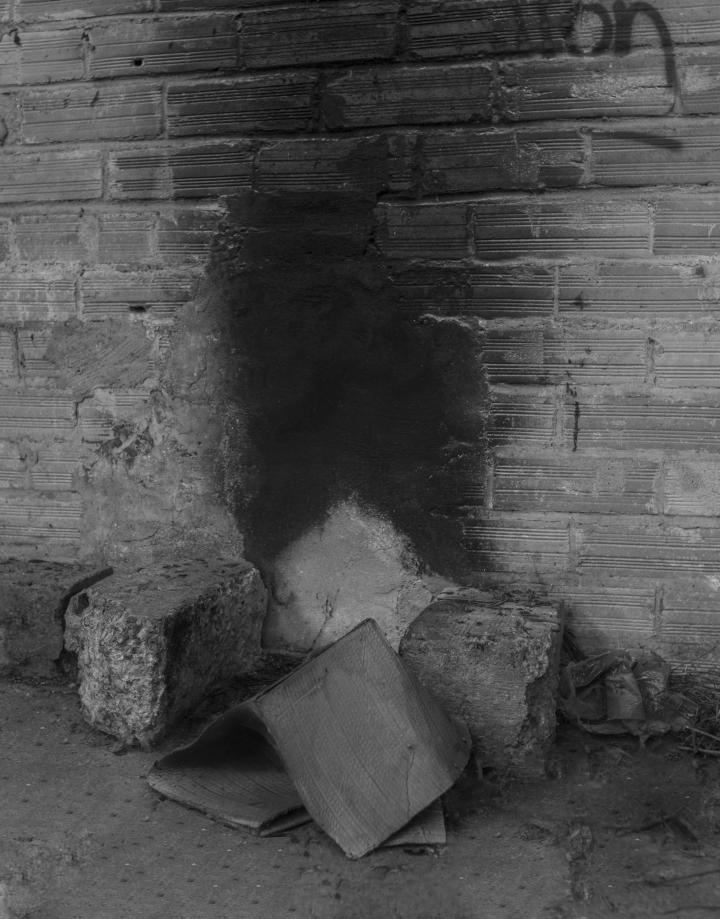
xmin=0 ymin=668 xmax=720 ymax=919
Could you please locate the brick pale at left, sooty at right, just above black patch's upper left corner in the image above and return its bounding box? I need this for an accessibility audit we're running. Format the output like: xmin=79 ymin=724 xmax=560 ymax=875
xmin=108 ymin=142 xmax=254 ymax=200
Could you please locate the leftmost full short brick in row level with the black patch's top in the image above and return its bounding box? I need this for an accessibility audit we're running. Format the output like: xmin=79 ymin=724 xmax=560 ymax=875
xmin=12 ymin=209 xmax=88 ymax=262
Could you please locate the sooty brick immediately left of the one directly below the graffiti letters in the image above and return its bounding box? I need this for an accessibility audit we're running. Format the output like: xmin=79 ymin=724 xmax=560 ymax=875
xmin=322 ymin=63 xmax=492 ymax=129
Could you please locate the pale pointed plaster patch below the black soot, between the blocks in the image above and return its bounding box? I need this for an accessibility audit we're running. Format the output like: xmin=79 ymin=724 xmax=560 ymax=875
xmin=264 ymin=501 xmax=444 ymax=650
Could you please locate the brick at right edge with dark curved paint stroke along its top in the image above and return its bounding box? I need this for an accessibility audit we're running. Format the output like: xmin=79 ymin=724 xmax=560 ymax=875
xmin=591 ymin=119 xmax=720 ymax=186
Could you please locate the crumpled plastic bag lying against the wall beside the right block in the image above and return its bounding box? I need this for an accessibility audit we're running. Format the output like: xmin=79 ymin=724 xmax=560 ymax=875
xmin=558 ymin=651 xmax=693 ymax=740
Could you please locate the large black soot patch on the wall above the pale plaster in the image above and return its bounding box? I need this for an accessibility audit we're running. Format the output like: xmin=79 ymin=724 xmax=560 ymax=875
xmin=211 ymin=193 xmax=484 ymax=578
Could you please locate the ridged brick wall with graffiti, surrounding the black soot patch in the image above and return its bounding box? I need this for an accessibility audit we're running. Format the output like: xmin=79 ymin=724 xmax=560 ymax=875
xmin=0 ymin=0 xmax=720 ymax=667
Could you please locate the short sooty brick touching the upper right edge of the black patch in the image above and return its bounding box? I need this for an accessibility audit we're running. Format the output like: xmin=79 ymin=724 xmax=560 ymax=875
xmin=376 ymin=203 xmax=470 ymax=259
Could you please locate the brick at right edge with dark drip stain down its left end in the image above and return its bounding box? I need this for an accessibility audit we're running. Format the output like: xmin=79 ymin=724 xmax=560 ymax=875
xmin=564 ymin=393 xmax=720 ymax=452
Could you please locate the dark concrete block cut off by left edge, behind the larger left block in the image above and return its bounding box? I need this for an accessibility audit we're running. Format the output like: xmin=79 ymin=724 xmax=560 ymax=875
xmin=0 ymin=559 xmax=108 ymax=676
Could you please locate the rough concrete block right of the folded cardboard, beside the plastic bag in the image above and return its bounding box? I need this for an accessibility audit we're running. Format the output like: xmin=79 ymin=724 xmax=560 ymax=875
xmin=400 ymin=590 xmax=562 ymax=776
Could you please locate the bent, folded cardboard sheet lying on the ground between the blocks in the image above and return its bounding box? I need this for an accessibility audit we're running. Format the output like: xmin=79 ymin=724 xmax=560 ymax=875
xmin=148 ymin=619 xmax=470 ymax=858
